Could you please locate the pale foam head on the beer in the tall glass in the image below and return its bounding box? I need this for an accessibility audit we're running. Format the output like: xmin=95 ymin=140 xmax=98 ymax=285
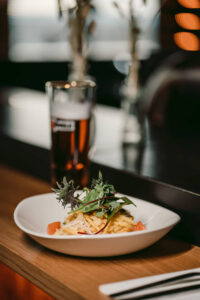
xmin=51 ymin=102 xmax=90 ymax=120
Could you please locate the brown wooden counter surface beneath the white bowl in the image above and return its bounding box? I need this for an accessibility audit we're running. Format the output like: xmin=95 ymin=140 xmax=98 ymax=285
xmin=0 ymin=166 xmax=200 ymax=300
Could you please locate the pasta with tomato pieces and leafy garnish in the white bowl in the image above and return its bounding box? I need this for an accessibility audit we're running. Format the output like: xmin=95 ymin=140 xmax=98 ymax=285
xmin=47 ymin=172 xmax=145 ymax=235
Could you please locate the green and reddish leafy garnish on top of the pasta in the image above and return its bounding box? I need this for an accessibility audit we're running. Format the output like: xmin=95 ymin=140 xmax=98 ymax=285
xmin=52 ymin=172 xmax=136 ymax=233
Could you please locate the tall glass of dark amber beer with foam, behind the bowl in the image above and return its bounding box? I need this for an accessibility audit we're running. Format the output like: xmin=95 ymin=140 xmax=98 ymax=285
xmin=46 ymin=80 xmax=96 ymax=187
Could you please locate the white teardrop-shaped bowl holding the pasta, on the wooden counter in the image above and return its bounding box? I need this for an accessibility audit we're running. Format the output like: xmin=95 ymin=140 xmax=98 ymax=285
xmin=14 ymin=193 xmax=180 ymax=257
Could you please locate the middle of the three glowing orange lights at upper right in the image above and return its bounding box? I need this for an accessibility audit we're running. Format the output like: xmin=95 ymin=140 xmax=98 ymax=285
xmin=175 ymin=13 xmax=200 ymax=30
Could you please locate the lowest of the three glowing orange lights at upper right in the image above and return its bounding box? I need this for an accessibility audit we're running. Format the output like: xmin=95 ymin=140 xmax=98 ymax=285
xmin=174 ymin=32 xmax=200 ymax=51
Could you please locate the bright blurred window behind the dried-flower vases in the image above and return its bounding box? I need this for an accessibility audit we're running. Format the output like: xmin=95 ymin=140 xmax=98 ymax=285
xmin=8 ymin=0 xmax=159 ymax=62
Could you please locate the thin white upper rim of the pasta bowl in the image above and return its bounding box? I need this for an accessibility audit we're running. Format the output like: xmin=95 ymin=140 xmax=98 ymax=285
xmin=13 ymin=193 xmax=181 ymax=240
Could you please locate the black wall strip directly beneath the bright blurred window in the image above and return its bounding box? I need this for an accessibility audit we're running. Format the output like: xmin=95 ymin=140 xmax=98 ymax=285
xmin=0 ymin=61 xmax=124 ymax=107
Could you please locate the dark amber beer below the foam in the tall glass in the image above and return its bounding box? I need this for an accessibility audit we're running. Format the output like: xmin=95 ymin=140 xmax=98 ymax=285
xmin=51 ymin=117 xmax=90 ymax=187
